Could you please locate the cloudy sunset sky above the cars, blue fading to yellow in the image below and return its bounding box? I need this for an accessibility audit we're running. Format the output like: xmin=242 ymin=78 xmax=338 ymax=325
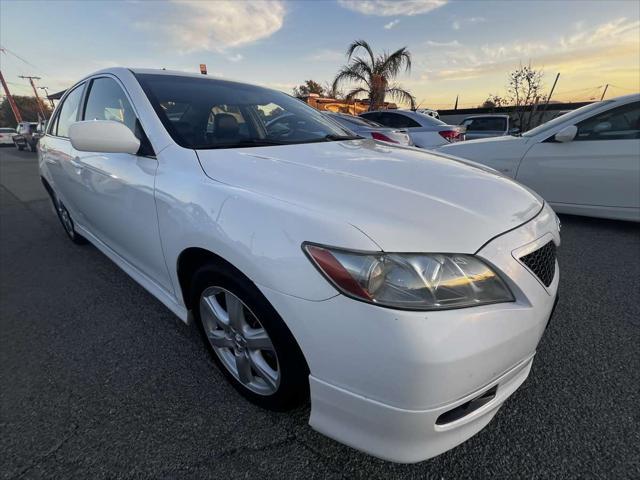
xmin=0 ymin=0 xmax=640 ymax=109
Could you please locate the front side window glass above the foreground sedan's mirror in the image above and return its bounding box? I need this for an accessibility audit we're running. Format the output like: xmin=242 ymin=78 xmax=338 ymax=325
xmin=84 ymin=77 xmax=136 ymax=133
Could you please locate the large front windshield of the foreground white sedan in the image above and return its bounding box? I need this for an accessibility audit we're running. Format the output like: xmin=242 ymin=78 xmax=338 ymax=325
xmin=136 ymin=74 xmax=359 ymax=149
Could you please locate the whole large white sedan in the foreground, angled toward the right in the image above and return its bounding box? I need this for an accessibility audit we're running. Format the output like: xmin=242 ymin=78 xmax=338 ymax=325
xmin=38 ymin=68 xmax=560 ymax=462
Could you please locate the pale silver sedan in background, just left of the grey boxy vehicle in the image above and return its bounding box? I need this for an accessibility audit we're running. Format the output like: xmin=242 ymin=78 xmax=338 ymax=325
xmin=360 ymin=110 xmax=464 ymax=148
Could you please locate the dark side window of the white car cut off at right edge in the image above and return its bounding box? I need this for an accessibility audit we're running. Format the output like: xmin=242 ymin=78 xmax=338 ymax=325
xmin=575 ymin=102 xmax=640 ymax=140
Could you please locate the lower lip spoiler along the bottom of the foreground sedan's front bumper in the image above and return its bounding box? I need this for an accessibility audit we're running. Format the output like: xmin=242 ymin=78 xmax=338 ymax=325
xmin=309 ymin=356 xmax=533 ymax=463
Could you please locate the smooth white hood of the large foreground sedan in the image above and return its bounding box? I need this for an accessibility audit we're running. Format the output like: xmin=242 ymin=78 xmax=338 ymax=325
xmin=197 ymin=140 xmax=542 ymax=253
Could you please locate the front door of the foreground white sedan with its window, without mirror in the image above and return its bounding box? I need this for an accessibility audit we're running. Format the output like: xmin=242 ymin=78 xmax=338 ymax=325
xmin=72 ymin=77 xmax=172 ymax=290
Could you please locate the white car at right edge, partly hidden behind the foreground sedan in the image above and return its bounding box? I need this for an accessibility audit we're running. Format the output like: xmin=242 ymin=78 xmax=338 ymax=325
xmin=440 ymin=94 xmax=640 ymax=221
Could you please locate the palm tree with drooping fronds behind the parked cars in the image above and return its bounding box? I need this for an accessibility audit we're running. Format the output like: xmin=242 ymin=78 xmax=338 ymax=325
xmin=333 ymin=40 xmax=416 ymax=110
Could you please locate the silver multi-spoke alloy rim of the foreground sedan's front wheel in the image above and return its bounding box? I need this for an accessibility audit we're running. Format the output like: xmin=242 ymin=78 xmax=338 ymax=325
xmin=200 ymin=287 xmax=280 ymax=395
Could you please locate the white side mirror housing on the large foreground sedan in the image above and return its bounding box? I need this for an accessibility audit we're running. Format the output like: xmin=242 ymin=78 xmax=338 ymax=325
xmin=69 ymin=120 xmax=140 ymax=155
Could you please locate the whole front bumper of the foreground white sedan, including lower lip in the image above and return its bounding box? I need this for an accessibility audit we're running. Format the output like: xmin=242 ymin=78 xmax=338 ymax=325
xmin=261 ymin=204 xmax=560 ymax=462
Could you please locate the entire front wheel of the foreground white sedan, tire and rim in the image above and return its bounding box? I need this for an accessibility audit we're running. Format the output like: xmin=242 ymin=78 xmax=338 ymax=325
xmin=191 ymin=264 xmax=309 ymax=411
